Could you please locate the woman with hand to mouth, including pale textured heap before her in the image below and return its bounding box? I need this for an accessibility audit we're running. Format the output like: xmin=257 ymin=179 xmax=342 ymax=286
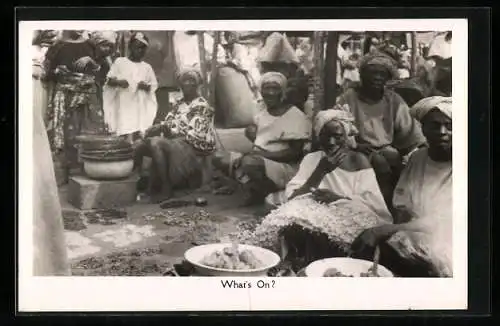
xmin=246 ymin=109 xmax=392 ymax=268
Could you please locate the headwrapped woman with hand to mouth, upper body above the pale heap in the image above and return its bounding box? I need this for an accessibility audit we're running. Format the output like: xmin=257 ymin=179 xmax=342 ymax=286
xmin=274 ymin=107 xmax=392 ymax=220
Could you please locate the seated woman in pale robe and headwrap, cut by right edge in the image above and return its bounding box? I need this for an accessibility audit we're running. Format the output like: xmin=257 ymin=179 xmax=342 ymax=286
xmin=353 ymin=96 xmax=453 ymax=277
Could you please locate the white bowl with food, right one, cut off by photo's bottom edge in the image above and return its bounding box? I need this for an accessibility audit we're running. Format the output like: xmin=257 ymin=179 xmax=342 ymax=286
xmin=305 ymin=257 xmax=394 ymax=277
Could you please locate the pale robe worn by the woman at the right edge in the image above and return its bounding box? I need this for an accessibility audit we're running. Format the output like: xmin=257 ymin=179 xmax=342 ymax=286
xmin=389 ymin=149 xmax=453 ymax=276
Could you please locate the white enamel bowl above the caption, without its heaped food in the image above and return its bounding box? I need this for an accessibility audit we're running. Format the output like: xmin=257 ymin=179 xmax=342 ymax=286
xmin=184 ymin=243 xmax=281 ymax=276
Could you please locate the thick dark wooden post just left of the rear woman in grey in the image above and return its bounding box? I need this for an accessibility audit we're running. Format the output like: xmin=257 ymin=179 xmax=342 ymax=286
xmin=324 ymin=31 xmax=339 ymax=108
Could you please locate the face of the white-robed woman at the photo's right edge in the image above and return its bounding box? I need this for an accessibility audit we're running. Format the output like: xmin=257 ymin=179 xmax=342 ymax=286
xmin=422 ymin=109 xmax=452 ymax=153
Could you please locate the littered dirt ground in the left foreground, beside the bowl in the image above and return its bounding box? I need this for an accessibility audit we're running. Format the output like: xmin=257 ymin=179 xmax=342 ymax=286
xmin=60 ymin=176 xmax=265 ymax=276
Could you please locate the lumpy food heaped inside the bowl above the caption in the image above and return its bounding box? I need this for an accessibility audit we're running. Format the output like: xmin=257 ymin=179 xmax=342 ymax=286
xmin=200 ymin=244 xmax=264 ymax=271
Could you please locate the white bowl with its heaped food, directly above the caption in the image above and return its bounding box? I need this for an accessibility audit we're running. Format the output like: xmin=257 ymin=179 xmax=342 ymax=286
xmin=184 ymin=243 xmax=281 ymax=276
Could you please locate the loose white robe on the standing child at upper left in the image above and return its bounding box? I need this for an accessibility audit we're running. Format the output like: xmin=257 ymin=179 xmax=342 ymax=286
xmin=103 ymin=57 xmax=158 ymax=136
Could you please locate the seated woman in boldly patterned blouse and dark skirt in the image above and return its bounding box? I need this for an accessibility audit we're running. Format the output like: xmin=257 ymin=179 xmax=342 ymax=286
xmin=136 ymin=68 xmax=215 ymax=202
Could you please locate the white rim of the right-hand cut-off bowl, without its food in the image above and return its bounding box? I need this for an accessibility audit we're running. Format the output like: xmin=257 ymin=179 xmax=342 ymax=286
xmin=305 ymin=257 xmax=394 ymax=277
